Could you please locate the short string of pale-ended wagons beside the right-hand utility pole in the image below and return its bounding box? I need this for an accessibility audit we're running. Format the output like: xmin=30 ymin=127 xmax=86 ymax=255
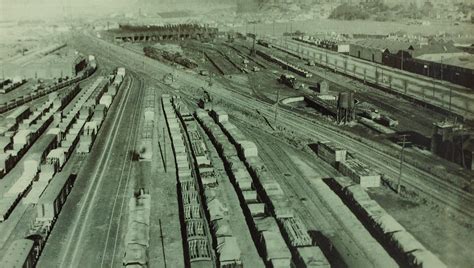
xmin=317 ymin=141 xmax=381 ymax=188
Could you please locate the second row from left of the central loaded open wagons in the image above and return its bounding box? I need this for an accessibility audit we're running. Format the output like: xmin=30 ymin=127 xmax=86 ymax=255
xmin=173 ymin=98 xmax=242 ymax=267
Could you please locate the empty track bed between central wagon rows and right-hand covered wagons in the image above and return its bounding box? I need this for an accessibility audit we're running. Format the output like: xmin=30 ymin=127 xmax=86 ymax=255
xmin=236 ymin=123 xmax=394 ymax=267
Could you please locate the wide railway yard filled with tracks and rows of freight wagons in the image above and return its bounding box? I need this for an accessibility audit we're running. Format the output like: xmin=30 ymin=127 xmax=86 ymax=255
xmin=0 ymin=28 xmax=474 ymax=267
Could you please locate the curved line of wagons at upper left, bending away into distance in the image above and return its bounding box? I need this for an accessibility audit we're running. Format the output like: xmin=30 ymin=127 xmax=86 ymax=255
xmin=0 ymin=55 xmax=97 ymax=113
